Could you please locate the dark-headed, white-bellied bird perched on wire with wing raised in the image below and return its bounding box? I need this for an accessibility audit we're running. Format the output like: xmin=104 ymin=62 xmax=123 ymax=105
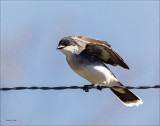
xmin=57 ymin=36 xmax=143 ymax=107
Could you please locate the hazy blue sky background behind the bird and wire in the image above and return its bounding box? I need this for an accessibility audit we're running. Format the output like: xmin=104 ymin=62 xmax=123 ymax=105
xmin=1 ymin=1 xmax=160 ymax=125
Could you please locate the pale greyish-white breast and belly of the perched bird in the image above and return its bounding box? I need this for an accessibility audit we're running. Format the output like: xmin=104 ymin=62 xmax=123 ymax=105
xmin=67 ymin=54 xmax=117 ymax=84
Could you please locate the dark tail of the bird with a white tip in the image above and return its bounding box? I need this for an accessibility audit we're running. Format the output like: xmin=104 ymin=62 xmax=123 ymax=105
xmin=111 ymin=82 xmax=143 ymax=107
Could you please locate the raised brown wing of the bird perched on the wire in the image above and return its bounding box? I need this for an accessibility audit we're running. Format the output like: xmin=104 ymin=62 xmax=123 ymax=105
xmin=74 ymin=36 xmax=129 ymax=69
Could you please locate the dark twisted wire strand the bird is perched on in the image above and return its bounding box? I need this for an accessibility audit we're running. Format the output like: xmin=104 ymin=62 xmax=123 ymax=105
xmin=0 ymin=85 xmax=160 ymax=92
